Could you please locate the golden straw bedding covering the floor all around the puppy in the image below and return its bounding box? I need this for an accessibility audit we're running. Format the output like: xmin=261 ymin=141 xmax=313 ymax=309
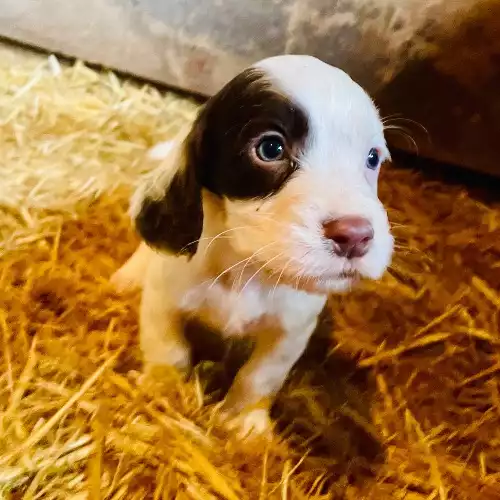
xmin=0 ymin=45 xmax=500 ymax=500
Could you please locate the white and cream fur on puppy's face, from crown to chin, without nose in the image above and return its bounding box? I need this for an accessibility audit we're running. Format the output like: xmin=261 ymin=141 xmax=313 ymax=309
xmin=221 ymin=56 xmax=393 ymax=292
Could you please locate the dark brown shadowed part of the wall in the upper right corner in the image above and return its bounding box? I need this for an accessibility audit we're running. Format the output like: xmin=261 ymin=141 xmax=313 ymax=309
xmin=374 ymin=1 xmax=500 ymax=180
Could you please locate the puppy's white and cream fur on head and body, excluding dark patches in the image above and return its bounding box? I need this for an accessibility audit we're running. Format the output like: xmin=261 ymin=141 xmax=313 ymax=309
xmin=115 ymin=56 xmax=393 ymax=442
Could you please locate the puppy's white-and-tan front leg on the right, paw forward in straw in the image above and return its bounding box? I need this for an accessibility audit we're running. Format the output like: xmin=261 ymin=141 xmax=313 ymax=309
xmin=223 ymin=317 xmax=317 ymax=438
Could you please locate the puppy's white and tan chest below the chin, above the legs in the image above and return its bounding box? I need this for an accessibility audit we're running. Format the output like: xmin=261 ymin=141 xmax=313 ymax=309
xmin=155 ymin=241 xmax=326 ymax=336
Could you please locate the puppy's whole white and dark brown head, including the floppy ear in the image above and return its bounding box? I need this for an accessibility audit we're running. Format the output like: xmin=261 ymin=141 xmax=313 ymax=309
xmin=135 ymin=56 xmax=393 ymax=291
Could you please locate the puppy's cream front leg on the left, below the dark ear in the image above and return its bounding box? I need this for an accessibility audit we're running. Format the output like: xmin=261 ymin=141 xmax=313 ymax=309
xmin=140 ymin=266 xmax=191 ymax=375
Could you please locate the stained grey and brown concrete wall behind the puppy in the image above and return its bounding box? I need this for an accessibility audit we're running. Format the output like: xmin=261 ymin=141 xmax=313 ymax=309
xmin=0 ymin=0 xmax=500 ymax=173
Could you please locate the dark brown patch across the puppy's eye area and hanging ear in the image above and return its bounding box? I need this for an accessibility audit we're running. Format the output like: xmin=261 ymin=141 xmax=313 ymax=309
xmin=135 ymin=69 xmax=308 ymax=255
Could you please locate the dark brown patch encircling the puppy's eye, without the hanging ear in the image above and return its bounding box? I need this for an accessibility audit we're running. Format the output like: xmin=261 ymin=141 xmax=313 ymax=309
xmin=186 ymin=69 xmax=308 ymax=199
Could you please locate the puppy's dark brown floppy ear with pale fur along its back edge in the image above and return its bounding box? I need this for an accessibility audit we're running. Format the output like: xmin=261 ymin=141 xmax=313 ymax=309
xmin=131 ymin=134 xmax=203 ymax=257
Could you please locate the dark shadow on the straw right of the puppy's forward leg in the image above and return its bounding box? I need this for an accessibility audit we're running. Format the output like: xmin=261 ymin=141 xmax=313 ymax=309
xmin=273 ymin=310 xmax=383 ymax=468
